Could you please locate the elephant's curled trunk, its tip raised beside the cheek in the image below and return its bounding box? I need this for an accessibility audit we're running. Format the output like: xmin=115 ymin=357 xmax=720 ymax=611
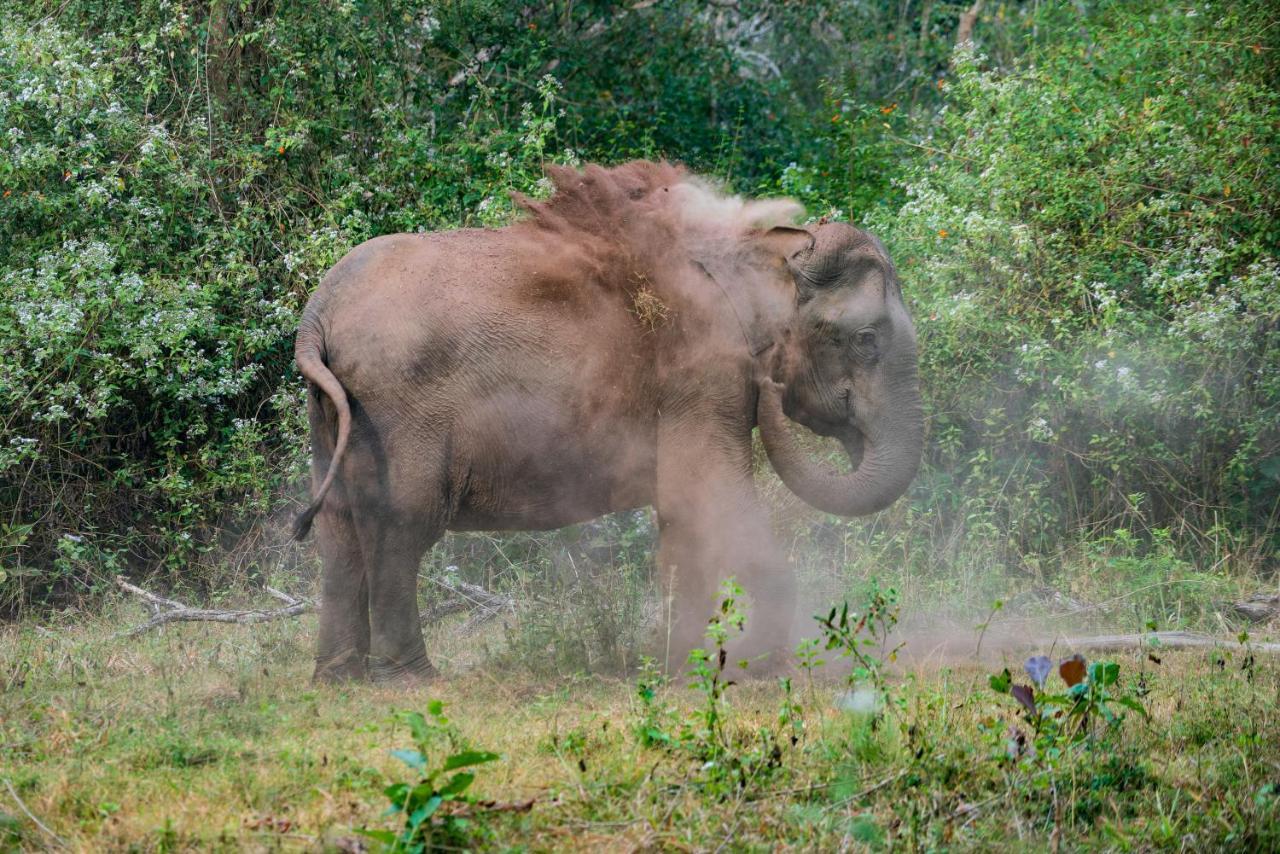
xmin=756 ymin=380 xmax=924 ymax=516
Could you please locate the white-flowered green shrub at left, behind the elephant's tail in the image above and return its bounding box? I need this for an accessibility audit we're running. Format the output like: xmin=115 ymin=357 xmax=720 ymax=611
xmin=0 ymin=15 xmax=320 ymax=603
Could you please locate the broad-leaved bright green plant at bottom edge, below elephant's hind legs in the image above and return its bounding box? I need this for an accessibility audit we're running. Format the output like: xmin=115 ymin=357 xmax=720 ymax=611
xmin=358 ymin=700 xmax=500 ymax=854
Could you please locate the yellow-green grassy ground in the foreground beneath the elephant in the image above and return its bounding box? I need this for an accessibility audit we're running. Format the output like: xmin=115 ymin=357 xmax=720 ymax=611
xmin=0 ymin=588 xmax=1280 ymax=850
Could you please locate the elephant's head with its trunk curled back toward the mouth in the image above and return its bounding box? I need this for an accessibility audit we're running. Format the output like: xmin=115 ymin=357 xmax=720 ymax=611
xmin=756 ymin=223 xmax=924 ymax=516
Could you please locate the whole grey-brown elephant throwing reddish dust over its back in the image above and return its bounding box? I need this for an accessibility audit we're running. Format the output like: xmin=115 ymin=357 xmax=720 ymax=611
xmin=294 ymin=161 xmax=924 ymax=681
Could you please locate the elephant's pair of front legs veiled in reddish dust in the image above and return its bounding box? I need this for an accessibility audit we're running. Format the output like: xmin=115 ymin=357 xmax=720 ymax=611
xmin=658 ymin=419 xmax=796 ymax=671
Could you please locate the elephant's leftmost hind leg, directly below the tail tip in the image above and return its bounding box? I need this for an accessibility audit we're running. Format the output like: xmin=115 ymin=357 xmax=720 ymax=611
xmin=314 ymin=501 xmax=369 ymax=681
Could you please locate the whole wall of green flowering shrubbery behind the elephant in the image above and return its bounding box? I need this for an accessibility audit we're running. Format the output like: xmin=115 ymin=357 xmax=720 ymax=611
xmin=0 ymin=0 xmax=1280 ymax=611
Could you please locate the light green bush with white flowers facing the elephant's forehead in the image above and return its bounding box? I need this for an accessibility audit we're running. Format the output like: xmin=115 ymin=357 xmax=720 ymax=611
xmin=872 ymin=4 xmax=1280 ymax=553
